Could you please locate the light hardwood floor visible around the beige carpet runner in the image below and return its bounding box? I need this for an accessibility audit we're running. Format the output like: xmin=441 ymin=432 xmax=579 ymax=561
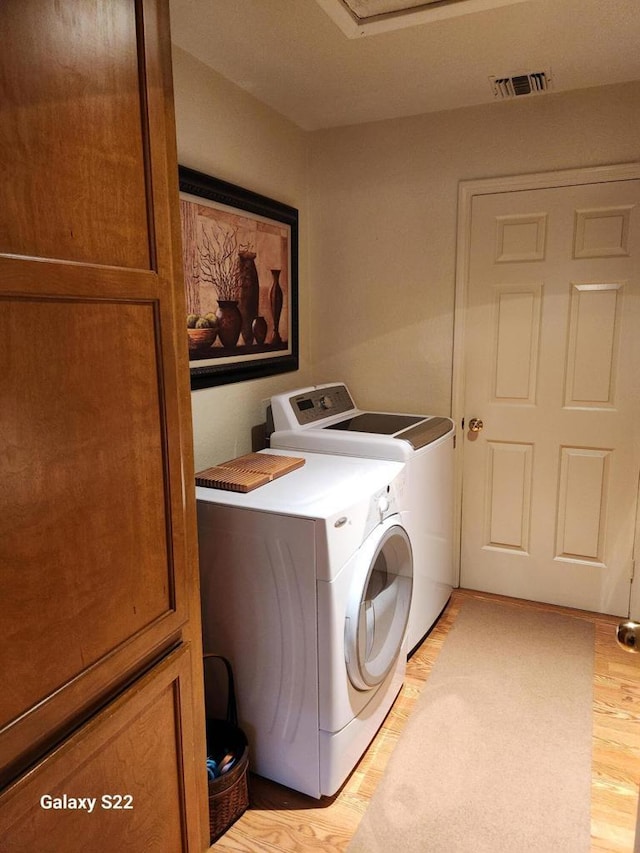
xmin=211 ymin=589 xmax=640 ymax=853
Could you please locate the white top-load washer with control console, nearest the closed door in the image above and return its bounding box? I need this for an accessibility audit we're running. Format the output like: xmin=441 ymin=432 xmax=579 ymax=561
xmin=269 ymin=383 xmax=455 ymax=651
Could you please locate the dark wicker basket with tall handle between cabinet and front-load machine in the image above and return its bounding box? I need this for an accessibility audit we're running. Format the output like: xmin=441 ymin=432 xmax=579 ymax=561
xmin=204 ymin=653 xmax=249 ymax=844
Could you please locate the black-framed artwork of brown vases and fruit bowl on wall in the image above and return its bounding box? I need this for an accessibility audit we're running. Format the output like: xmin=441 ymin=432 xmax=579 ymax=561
xmin=179 ymin=166 xmax=298 ymax=389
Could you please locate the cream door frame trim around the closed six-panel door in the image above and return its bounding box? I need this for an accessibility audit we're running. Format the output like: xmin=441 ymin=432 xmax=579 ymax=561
xmin=451 ymin=162 xmax=640 ymax=584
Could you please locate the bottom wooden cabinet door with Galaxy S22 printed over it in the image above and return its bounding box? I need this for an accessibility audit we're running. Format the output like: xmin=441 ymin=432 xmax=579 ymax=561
xmin=0 ymin=645 xmax=200 ymax=853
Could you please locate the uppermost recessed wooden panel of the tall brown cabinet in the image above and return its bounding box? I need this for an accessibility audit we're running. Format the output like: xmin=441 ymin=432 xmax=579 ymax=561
xmin=0 ymin=0 xmax=150 ymax=268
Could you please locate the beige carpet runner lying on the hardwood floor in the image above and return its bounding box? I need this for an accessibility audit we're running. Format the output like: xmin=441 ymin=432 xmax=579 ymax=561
xmin=348 ymin=600 xmax=594 ymax=853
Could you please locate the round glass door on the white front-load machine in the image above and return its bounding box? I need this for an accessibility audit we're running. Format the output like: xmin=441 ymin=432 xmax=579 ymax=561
xmin=345 ymin=515 xmax=413 ymax=690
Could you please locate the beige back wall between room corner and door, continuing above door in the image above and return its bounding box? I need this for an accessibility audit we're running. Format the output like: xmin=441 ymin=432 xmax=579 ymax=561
xmin=309 ymin=83 xmax=640 ymax=414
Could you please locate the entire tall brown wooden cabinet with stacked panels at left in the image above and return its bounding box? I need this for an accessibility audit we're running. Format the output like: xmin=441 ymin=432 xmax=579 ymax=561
xmin=0 ymin=0 xmax=206 ymax=853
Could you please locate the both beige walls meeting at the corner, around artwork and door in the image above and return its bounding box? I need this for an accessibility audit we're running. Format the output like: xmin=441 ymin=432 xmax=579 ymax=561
xmin=174 ymin=46 xmax=640 ymax=462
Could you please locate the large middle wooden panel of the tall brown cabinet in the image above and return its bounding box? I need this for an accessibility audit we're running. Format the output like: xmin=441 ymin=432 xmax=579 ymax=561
xmin=0 ymin=286 xmax=191 ymax=776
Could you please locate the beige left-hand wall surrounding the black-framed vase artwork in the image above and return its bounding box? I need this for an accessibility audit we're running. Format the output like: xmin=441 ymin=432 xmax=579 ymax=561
xmin=173 ymin=45 xmax=310 ymax=470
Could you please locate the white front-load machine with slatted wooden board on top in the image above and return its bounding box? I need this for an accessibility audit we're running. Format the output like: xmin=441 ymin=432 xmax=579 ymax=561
xmin=196 ymin=450 xmax=413 ymax=797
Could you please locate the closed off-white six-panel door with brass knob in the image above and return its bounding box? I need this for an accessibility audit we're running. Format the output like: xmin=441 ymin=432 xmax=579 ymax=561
xmin=461 ymin=180 xmax=640 ymax=614
